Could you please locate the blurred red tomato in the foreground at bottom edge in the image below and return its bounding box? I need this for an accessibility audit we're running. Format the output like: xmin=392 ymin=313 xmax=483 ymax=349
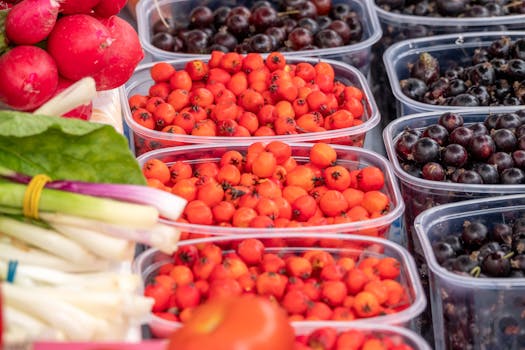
xmin=167 ymin=295 xmax=295 ymax=350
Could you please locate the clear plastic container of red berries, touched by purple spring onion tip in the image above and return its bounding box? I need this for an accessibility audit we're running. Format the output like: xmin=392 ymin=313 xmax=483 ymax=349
xmin=137 ymin=143 xmax=404 ymax=238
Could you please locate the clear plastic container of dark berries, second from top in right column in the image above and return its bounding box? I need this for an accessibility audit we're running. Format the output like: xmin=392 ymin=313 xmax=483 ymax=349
xmin=383 ymin=31 xmax=525 ymax=118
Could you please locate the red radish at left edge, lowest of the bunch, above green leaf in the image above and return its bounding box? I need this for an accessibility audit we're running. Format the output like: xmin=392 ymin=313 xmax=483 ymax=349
xmin=0 ymin=45 xmax=58 ymax=111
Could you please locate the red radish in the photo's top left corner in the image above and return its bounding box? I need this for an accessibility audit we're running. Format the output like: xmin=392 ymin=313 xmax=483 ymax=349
xmin=5 ymin=0 xmax=59 ymax=45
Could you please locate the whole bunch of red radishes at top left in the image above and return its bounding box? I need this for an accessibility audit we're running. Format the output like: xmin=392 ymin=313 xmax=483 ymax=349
xmin=0 ymin=0 xmax=144 ymax=117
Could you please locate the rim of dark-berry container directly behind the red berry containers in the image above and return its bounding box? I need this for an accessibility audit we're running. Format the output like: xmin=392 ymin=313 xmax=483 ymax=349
xmin=137 ymin=0 xmax=383 ymax=59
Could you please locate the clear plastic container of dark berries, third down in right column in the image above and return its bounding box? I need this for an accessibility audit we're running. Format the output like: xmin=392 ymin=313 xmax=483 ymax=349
xmin=383 ymin=107 xmax=525 ymax=253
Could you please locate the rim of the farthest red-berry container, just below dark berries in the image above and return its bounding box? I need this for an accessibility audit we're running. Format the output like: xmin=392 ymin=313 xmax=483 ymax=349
xmin=119 ymin=56 xmax=381 ymax=144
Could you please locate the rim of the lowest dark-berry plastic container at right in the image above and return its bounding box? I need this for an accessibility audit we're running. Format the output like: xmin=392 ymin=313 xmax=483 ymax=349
xmin=414 ymin=194 xmax=525 ymax=289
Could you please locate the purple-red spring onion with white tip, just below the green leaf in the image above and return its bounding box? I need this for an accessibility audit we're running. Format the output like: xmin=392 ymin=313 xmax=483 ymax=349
xmin=0 ymin=166 xmax=186 ymax=220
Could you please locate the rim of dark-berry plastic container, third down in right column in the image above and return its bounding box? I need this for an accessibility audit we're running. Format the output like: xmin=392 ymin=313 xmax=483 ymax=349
xmin=383 ymin=106 xmax=525 ymax=193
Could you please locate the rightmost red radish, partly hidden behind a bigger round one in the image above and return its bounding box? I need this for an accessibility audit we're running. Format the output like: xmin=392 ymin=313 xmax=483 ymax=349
xmin=93 ymin=16 xmax=144 ymax=90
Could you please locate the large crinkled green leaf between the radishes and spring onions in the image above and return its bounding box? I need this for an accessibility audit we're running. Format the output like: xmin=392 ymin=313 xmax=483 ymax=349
xmin=0 ymin=111 xmax=145 ymax=184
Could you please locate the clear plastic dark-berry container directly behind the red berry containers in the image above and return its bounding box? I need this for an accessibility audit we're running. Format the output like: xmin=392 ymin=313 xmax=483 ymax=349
xmin=137 ymin=0 xmax=382 ymax=74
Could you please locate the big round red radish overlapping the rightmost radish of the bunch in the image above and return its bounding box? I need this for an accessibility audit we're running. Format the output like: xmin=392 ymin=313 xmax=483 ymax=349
xmin=47 ymin=14 xmax=113 ymax=80
